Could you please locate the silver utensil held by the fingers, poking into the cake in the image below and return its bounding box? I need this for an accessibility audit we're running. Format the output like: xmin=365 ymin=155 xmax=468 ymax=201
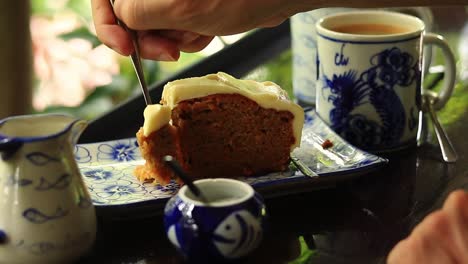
xmin=110 ymin=0 xmax=152 ymax=105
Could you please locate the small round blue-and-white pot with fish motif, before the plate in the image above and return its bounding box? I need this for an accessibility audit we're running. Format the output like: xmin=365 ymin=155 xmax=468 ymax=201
xmin=164 ymin=178 xmax=266 ymax=263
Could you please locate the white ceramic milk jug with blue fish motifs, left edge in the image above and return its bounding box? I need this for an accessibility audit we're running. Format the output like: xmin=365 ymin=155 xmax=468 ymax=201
xmin=0 ymin=115 xmax=96 ymax=264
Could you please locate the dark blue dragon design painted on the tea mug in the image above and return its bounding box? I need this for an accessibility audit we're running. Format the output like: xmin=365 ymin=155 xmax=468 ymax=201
xmin=322 ymin=47 xmax=421 ymax=149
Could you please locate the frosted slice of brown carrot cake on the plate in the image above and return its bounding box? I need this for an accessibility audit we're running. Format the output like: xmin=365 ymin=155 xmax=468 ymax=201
xmin=135 ymin=72 xmax=304 ymax=184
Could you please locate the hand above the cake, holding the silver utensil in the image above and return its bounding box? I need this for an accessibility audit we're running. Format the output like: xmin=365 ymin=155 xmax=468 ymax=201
xmin=92 ymin=0 xmax=298 ymax=60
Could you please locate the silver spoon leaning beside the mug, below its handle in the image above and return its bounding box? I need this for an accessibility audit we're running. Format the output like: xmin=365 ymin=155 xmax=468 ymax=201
xmin=422 ymin=93 xmax=458 ymax=162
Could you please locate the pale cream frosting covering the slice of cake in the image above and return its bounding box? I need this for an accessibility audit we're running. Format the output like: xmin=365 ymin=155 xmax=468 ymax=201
xmin=143 ymin=72 xmax=304 ymax=150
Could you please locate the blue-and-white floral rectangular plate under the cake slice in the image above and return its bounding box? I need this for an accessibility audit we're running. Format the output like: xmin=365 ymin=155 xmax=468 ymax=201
xmin=75 ymin=109 xmax=387 ymax=207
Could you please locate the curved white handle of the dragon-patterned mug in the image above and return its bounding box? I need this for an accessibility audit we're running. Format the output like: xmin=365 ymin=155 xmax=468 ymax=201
xmin=423 ymin=33 xmax=456 ymax=110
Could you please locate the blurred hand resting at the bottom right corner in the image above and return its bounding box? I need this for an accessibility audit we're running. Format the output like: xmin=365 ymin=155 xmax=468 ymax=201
xmin=387 ymin=191 xmax=468 ymax=264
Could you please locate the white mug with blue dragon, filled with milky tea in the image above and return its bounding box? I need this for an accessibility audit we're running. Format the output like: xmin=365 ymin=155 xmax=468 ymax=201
xmin=316 ymin=11 xmax=455 ymax=152
